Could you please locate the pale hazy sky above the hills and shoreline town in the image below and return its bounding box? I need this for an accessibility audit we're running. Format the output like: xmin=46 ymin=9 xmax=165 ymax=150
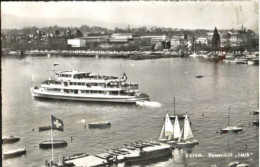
xmin=1 ymin=1 xmax=259 ymax=31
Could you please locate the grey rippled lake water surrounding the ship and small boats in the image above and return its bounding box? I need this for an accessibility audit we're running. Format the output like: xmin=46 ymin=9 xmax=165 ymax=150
xmin=2 ymin=56 xmax=259 ymax=167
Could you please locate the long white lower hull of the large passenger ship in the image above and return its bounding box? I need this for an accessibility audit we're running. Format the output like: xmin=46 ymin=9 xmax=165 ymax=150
xmin=31 ymin=88 xmax=149 ymax=103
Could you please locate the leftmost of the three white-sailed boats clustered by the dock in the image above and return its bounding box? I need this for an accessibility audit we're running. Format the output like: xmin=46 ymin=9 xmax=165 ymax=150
xmin=159 ymin=113 xmax=173 ymax=142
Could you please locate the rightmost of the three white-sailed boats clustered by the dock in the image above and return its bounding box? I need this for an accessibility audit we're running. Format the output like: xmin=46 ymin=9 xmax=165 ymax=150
xmin=176 ymin=115 xmax=199 ymax=146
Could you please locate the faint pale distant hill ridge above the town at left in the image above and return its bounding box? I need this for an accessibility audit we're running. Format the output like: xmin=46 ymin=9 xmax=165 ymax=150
xmin=1 ymin=14 xmax=132 ymax=29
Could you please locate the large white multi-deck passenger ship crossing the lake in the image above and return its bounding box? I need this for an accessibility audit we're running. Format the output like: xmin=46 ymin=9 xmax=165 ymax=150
xmin=30 ymin=70 xmax=149 ymax=103
